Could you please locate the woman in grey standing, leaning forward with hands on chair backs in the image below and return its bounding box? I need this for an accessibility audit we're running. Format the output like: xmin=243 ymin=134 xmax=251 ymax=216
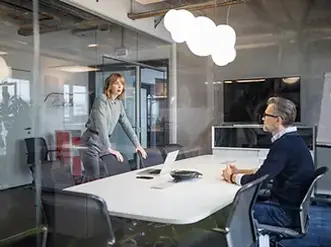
xmin=80 ymin=73 xmax=147 ymax=179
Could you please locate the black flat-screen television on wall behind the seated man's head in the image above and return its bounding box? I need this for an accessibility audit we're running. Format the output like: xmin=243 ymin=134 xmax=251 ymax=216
xmin=222 ymin=76 xmax=301 ymax=124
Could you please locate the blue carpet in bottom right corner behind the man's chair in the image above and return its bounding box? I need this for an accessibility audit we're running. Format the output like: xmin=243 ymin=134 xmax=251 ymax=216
xmin=281 ymin=204 xmax=331 ymax=247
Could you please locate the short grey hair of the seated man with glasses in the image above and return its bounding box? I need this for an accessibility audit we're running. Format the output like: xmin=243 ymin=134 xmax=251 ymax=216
xmin=267 ymin=97 xmax=297 ymax=127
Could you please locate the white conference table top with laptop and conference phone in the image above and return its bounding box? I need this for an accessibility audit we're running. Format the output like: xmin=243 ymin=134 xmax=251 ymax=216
xmin=66 ymin=155 xmax=257 ymax=225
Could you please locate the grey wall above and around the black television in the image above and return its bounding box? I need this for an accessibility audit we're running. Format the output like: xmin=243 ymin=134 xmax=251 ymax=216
xmin=209 ymin=0 xmax=331 ymax=194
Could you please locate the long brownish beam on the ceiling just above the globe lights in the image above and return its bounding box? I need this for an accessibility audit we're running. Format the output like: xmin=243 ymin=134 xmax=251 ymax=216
xmin=128 ymin=0 xmax=249 ymax=20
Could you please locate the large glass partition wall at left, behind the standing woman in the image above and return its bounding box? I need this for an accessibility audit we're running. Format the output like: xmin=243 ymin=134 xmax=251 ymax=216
xmin=0 ymin=0 xmax=170 ymax=246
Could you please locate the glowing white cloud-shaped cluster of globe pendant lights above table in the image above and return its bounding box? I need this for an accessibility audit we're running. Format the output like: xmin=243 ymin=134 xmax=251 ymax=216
xmin=164 ymin=9 xmax=237 ymax=66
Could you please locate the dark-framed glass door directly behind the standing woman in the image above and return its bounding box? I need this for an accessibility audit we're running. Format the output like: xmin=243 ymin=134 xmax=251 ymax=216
xmin=94 ymin=55 xmax=168 ymax=165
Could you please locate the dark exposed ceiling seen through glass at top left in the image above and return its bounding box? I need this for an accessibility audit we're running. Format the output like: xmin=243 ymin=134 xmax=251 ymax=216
xmin=0 ymin=0 xmax=111 ymax=36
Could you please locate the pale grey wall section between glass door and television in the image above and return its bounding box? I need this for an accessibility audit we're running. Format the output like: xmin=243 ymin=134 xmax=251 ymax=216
xmin=177 ymin=44 xmax=213 ymax=152
